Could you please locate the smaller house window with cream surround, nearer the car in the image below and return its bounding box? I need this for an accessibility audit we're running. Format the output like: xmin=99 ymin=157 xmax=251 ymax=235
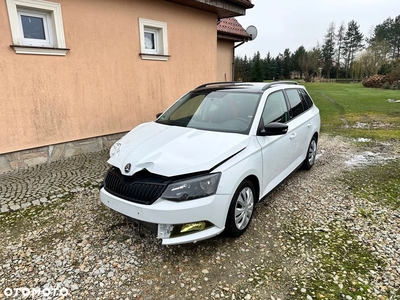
xmin=139 ymin=18 xmax=170 ymax=61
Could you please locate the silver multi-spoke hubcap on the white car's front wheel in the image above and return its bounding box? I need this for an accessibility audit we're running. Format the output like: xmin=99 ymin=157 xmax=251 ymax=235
xmin=235 ymin=187 xmax=254 ymax=230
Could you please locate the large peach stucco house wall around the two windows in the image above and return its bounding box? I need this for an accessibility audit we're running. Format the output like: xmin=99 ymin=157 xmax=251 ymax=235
xmin=0 ymin=0 xmax=220 ymax=154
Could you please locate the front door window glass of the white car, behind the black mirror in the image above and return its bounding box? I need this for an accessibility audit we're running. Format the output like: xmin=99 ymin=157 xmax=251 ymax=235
xmin=262 ymin=91 xmax=289 ymax=126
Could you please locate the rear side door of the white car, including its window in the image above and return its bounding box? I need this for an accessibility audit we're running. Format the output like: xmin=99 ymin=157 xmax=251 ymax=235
xmin=285 ymin=88 xmax=314 ymax=165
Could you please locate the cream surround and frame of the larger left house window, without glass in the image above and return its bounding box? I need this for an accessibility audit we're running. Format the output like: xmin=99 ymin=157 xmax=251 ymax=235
xmin=6 ymin=0 xmax=69 ymax=55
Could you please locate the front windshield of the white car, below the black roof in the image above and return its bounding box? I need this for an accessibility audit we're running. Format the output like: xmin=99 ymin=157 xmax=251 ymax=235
xmin=156 ymin=91 xmax=261 ymax=134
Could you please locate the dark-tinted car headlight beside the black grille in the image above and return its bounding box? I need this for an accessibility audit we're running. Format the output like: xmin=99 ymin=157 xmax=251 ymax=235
xmin=161 ymin=173 xmax=221 ymax=201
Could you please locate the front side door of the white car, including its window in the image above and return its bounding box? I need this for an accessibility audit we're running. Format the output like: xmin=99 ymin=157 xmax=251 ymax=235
xmin=257 ymin=90 xmax=294 ymax=196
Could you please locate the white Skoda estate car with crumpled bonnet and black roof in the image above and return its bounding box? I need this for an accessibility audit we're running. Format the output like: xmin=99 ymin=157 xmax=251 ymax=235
xmin=100 ymin=82 xmax=320 ymax=245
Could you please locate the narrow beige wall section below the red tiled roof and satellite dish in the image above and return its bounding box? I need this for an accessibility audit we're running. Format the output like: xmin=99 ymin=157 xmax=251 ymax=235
xmin=217 ymin=39 xmax=234 ymax=81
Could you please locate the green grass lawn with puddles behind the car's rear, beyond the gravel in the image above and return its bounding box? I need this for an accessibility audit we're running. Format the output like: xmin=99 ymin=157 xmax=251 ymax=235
xmin=304 ymin=83 xmax=400 ymax=140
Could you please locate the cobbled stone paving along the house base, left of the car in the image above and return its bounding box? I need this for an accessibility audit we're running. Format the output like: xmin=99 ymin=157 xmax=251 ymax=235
xmin=0 ymin=150 xmax=109 ymax=213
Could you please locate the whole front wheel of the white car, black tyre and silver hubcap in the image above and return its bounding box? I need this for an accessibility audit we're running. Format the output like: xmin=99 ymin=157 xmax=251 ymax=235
xmin=225 ymin=180 xmax=256 ymax=237
